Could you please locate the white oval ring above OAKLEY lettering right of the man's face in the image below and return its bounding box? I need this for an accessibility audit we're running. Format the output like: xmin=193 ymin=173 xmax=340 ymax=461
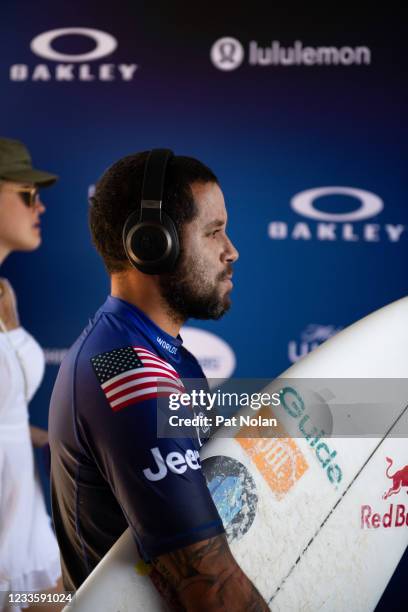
xmin=290 ymin=187 xmax=384 ymax=221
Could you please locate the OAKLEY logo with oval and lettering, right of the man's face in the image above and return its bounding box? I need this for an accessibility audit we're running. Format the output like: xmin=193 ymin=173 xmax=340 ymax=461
xmin=268 ymin=186 xmax=405 ymax=242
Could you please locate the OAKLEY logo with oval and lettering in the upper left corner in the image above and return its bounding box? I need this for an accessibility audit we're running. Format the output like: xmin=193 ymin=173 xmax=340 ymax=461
xmin=10 ymin=28 xmax=138 ymax=82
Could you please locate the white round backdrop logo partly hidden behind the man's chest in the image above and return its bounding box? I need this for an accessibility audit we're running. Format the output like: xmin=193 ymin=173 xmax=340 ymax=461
xmin=180 ymin=327 xmax=236 ymax=388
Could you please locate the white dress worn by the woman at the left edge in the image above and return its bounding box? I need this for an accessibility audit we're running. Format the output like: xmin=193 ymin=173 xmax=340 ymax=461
xmin=0 ymin=327 xmax=61 ymax=609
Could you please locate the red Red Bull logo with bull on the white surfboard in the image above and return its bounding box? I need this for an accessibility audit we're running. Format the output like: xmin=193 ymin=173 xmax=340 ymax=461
xmin=361 ymin=457 xmax=408 ymax=529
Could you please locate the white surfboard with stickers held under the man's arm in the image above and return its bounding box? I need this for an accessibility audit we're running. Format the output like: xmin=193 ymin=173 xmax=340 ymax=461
xmin=64 ymin=298 xmax=408 ymax=612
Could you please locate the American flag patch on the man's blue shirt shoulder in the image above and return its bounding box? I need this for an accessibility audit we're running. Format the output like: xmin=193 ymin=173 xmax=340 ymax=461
xmin=91 ymin=346 xmax=185 ymax=412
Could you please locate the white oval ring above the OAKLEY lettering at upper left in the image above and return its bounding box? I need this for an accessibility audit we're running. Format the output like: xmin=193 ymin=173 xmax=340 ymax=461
xmin=30 ymin=28 xmax=118 ymax=62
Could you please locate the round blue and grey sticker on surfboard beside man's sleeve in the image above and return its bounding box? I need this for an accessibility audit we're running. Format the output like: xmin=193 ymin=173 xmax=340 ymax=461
xmin=201 ymin=455 xmax=258 ymax=542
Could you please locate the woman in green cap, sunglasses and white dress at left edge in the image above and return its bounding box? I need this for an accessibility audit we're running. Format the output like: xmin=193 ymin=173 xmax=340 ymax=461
xmin=0 ymin=138 xmax=64 ymax=612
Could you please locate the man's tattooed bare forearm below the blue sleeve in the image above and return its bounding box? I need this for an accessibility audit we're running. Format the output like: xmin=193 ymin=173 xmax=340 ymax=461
xmin=153 ymin=535 xmax=268 ymax=612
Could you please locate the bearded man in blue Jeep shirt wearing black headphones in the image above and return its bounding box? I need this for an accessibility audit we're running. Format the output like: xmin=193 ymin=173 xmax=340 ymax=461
xmin=49 ymin=149 xmax=268 ymax=611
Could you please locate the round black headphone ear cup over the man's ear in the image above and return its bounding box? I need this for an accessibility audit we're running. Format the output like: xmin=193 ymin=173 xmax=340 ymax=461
xmin=123 ymin=211 xmax=180 ymax=274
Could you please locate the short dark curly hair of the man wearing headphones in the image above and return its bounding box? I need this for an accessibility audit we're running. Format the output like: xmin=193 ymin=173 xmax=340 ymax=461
xmin=89 ymin=151 xmax=218 ymax=274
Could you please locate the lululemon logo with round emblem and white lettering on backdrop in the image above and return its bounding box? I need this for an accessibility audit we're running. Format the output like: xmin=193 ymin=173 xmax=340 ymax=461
xmin=210 ymin=36 xmax=371 ymax=71
